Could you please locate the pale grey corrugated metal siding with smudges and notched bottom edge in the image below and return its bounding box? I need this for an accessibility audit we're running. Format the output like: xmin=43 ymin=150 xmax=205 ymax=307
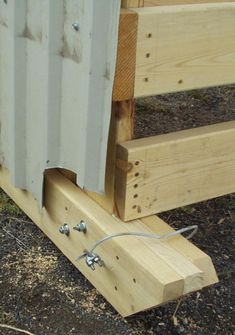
xmin=0 ymin=0 xmax=120 ymax=205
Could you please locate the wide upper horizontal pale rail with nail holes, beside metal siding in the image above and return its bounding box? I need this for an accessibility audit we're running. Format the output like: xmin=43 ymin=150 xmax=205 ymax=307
xmin=114 ymin=2 xmax=235 ymax=100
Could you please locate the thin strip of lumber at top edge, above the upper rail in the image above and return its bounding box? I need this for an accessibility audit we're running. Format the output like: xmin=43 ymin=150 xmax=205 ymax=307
xmin=122 ymin=0 xmax=234 ymax=8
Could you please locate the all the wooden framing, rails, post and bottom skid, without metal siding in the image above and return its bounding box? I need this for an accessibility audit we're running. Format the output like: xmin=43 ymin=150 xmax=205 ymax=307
xmin=0 ymin=0 xmax=235 ymax=316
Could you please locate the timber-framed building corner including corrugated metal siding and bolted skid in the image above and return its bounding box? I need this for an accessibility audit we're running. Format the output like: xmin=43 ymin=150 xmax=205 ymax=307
xmin=0 ymin=0 xmax=235 ymax=316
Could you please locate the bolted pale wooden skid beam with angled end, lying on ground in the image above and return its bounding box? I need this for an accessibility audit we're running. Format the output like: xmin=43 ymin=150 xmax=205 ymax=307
xmin=0 ymin=168 xmax=217 ymax=316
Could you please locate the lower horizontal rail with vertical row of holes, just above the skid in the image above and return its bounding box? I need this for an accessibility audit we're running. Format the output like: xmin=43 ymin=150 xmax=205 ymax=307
xmin=116 ymin=121 xmax=235 ymax=220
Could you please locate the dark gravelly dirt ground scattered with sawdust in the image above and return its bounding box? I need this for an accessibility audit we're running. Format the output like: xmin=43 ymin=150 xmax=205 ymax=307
xmin=0 ymin=86 xmax=235 ymax=335
